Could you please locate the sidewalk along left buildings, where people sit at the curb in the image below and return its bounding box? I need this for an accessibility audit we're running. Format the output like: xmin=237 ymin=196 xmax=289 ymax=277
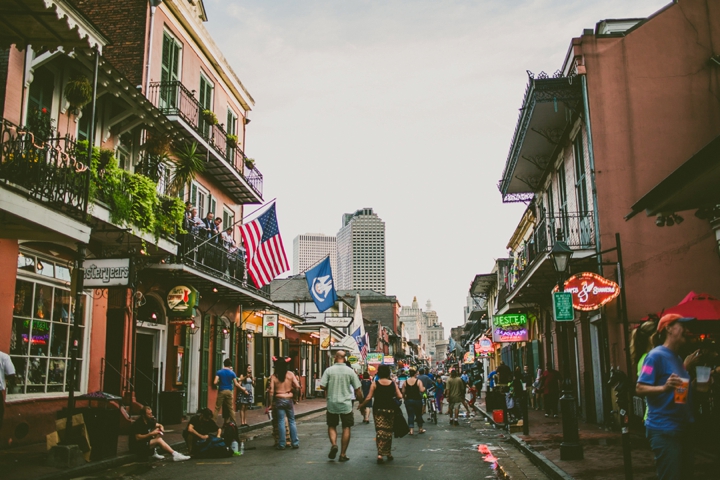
xmin=0 ymin=398 xmax=326 ymax=480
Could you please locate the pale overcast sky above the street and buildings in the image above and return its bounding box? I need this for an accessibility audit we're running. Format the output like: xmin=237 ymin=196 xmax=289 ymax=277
xmin=204 ymin=0 xmax=669 ymax=335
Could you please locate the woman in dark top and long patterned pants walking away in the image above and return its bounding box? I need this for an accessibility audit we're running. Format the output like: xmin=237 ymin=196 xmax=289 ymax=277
xmin=358 ymin=365 xmax=402 ymax=463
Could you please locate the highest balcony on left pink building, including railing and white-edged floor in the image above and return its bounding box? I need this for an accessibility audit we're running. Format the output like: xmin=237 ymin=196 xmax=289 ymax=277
xmin=148 ymin=81 xmax=263 ymax=204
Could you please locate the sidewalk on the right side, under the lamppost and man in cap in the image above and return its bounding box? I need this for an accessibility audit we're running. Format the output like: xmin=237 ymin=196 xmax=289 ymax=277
xmin=476 ymin=399 xmax=717 ymax=480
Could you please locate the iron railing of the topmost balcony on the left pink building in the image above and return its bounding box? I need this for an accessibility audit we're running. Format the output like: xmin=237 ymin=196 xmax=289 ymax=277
xmin=148 ymin=81 xmax=263 ymax=197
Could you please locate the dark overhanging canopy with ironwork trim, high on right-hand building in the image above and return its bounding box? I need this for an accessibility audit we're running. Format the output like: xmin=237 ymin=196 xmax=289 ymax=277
xmin=498 ymin=72 xmax=582 ymax=202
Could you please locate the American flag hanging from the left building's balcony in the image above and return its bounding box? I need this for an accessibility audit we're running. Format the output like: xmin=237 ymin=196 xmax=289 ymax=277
xmin=240 ymin=203 xmax=290 ymax=288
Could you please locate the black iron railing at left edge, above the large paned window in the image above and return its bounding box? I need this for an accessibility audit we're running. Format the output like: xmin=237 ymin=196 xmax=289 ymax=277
xmin=0 ymin=119 xmax=90 ymax=219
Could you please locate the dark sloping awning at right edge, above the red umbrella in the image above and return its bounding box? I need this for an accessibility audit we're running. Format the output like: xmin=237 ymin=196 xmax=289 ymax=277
xmin=625 ymin=136 xmax=720 ymax=220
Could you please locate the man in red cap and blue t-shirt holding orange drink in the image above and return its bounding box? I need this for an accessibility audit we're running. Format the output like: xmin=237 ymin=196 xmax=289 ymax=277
xmin=636 ymin=314 xmax=695 ymax=480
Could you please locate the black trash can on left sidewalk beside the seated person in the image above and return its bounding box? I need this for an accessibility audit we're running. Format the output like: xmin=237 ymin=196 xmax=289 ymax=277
xmin=58 ymin=407 xmax=120 ymax=461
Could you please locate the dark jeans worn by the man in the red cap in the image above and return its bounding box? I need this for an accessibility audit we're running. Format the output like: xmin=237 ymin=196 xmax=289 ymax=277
xmin=646 ymin=428 xmax=694 ymax=480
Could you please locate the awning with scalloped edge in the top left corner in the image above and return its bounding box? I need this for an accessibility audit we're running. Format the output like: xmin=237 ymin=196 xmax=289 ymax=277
xmin=0 ymin=0 xmax=108 ymax=52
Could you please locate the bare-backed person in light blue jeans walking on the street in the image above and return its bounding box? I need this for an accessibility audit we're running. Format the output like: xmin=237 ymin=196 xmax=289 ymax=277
xmin=270 ymin=357 xmax=300 ymax=450
